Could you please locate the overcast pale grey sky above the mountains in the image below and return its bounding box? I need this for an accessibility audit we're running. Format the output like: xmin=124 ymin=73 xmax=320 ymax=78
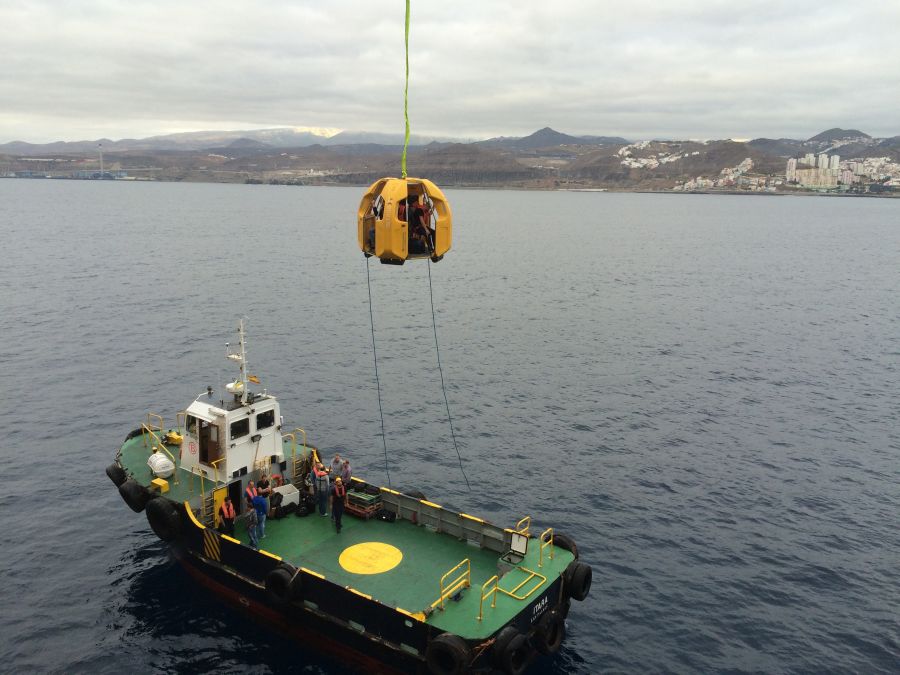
xmin=0 ymin=0 xmax=900 ymax=142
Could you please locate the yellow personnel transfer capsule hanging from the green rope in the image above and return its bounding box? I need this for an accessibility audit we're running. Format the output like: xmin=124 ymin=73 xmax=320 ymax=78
xmin=357 ymin=178 xmax=453 ymax=265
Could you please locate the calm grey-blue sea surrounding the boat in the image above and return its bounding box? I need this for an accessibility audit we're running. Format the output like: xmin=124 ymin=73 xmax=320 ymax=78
xmin=0 ymin=180 xmax=900 ymax=674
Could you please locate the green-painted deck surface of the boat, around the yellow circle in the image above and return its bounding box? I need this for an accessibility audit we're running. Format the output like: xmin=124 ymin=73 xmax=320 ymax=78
xmin=121 ymin=428 xmax=573 ymax=639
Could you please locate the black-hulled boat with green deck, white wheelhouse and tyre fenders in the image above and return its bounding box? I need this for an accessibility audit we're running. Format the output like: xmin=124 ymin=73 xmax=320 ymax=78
xmin=106 ymin=320 xmax=592 ymax=675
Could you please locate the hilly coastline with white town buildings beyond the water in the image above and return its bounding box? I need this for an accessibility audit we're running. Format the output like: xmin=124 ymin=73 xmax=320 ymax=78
xmin=0 ymin=127 xmax=900 ymax=196
